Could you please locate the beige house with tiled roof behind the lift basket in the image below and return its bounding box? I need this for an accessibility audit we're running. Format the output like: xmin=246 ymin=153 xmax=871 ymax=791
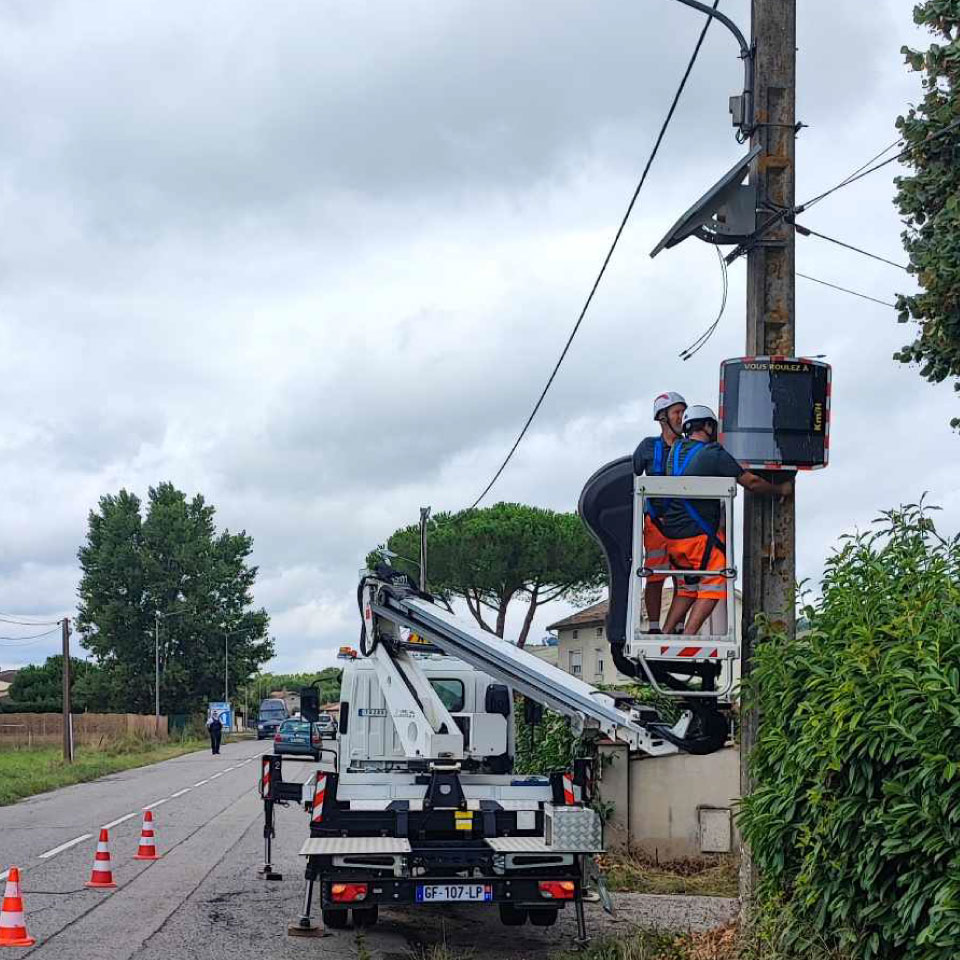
xmin=548 ymin=582 xmax=741 ymax=686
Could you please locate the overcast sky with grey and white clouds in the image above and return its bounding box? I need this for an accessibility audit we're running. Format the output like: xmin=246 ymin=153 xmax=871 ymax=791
xmin=0 ymin=0 xmax=960 ymax=669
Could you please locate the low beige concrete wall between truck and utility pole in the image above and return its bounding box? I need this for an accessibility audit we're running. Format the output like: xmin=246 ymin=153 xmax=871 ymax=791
xmin=598 ymin=744 xmax=740 ymax=860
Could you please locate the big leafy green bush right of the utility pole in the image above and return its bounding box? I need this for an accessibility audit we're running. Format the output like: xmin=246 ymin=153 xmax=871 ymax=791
xmin=740 ymin=504 xmax=960 ymax=960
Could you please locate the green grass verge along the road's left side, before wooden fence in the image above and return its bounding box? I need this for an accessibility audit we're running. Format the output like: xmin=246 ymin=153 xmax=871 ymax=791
xmin=0 ymin=738 xmax=206 ymax=806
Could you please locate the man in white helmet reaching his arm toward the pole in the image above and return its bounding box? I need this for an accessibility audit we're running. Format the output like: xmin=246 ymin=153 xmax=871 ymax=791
xmin=661 ymin=404 xmax=793 ymax=634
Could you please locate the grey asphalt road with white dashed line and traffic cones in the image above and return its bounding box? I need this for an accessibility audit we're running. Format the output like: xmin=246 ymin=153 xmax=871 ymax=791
xmin=0 ymin=742 xmax=735 ymax=960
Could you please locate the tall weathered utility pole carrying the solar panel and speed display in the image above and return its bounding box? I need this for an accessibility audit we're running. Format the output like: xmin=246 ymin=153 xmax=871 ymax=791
xmin=740 ymin=0 xmax=797 ymax=907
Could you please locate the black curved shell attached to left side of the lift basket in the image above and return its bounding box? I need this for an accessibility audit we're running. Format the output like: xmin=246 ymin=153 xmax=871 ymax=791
xmin=577 ymin=457 xmax=634 ymax=647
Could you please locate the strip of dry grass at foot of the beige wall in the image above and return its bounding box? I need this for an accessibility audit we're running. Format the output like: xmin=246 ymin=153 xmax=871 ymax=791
xmin=602 ymin=853 xmax=738 ymax=897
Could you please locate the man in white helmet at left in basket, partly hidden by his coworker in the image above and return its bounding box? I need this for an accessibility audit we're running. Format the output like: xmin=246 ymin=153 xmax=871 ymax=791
xmin=633 ymin=391 xmax=687 ymax=633
